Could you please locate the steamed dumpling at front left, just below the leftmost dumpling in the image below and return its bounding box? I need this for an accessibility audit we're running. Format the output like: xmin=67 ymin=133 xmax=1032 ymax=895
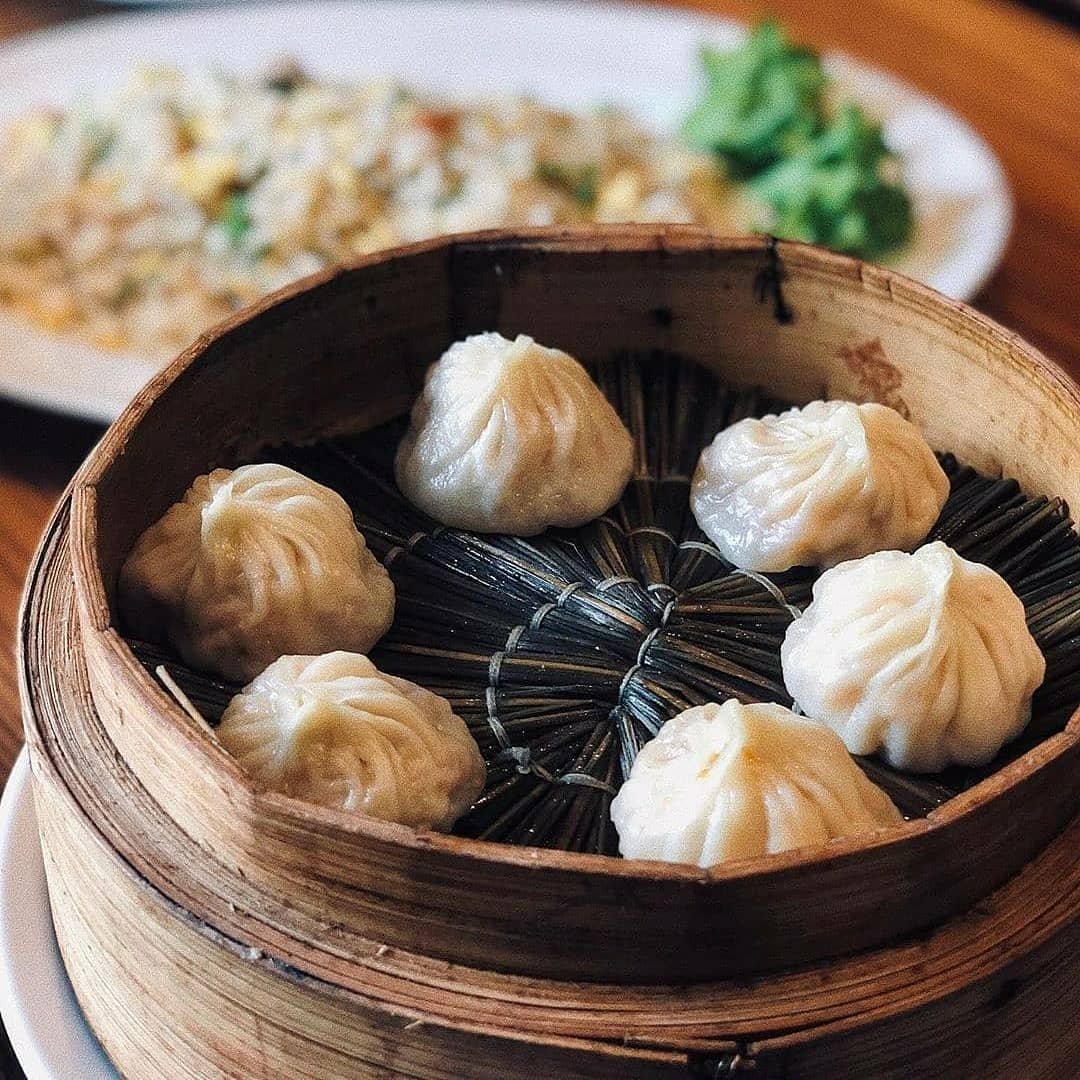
xmin=217 ymin=652 xmax=485 ymax=829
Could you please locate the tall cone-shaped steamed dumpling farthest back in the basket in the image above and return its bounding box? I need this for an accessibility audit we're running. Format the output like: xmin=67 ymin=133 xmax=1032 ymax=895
xmin=395 ymin=334 xmax=634 ymax=536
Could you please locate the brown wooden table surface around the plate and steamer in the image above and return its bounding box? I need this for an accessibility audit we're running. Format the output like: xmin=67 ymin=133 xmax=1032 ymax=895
xmin=0 ymin=0 xmax=1080 ymax=781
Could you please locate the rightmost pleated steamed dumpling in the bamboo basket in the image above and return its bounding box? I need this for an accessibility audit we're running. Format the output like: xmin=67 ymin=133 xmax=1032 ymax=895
xmin=781 ymin=541 xmax=1047 ymax=772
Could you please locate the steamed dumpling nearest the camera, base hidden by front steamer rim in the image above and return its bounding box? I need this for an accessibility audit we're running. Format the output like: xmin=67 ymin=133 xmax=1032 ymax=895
xmin=611 ymin=698 xmax=902 ymax=866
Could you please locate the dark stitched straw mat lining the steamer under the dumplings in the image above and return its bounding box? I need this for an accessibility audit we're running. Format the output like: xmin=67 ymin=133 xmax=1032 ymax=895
xmin=131 ymin=351 xmax=1080 ymax=853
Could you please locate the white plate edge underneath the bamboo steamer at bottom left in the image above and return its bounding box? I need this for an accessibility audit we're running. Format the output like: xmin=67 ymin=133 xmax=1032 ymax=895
xmin=0 ymin=751 xmax=119 ymax=1080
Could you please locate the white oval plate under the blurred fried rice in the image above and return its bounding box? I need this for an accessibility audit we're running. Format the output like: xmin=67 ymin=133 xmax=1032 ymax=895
xmin=0 ymin=0 xmax=1011 ymax=420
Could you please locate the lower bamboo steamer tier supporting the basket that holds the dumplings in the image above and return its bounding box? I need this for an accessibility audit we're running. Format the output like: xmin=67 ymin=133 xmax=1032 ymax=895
xmin=19 ymin=500 xmax=1080 ymax=1080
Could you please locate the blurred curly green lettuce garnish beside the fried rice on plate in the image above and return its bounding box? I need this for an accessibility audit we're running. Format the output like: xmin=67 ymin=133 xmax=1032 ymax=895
xmin=684 ymin=22 xmax=912 ymax=258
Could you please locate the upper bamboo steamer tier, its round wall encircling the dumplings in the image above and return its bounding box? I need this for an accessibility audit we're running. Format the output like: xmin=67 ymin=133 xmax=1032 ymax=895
xmin=65 ymin=227 xmax=1080 ymax=983
